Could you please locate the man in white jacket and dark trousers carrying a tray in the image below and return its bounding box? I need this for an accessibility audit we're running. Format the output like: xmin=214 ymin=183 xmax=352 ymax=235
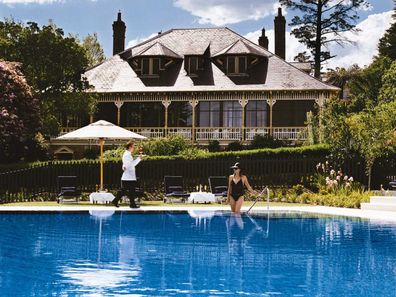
xmin=112 ymin=141 xmax=143 ymax=208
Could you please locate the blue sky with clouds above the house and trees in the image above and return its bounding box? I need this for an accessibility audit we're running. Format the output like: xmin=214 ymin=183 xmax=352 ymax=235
xmin=0 ymin=0 xmax=393 ymax=68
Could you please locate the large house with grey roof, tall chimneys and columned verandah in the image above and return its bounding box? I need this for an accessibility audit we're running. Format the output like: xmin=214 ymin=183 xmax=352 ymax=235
xmin=51 ymin=9 xmax=339 ymax=157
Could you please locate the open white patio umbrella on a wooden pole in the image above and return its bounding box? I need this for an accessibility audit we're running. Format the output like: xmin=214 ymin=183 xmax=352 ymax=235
xmin=57 ymin=120 xmax=146 ymax=190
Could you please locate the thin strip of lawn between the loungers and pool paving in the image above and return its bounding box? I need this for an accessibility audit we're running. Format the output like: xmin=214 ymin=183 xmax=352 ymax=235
xmin=0 ymin=201 xmax=307 ymax=208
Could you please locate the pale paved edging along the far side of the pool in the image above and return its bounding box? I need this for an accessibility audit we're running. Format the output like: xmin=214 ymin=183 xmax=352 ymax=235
xmin=0 ymin=205 xmax=396 ymax=223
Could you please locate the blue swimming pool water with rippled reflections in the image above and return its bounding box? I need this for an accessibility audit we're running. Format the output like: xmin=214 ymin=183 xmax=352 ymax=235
xmin=0 ymin=212 xmax=396 ymax=297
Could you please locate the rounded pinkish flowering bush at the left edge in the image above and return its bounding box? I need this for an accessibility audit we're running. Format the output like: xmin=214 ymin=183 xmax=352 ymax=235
xmin=0 ymin=60 xmax=41 ymax=163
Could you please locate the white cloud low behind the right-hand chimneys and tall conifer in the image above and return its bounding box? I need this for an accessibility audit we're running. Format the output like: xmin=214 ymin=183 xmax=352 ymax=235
xmin=245 ymin=11 xmax=393 ymax=69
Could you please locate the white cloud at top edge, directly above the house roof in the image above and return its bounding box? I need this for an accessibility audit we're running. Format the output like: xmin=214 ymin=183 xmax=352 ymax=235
xmin=173 ymin=0 xmax=279 ymax=26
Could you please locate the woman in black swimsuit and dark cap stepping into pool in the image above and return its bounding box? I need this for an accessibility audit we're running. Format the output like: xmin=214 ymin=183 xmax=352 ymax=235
xmin=227 ymin=162 xmax=257 ymax=214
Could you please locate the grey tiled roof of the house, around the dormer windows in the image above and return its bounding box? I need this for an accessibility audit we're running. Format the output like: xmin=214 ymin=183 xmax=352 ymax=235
xmin=85 ymin=28 xmax=338 ymax=92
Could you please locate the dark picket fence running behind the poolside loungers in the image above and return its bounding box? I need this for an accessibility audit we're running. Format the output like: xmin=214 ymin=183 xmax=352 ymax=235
xmin=0 ymin=154 xmax=396 ymax=203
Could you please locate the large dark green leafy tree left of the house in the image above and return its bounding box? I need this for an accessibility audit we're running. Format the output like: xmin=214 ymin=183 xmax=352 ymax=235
xmin=0 ymin=19 xmax=93 ymax=135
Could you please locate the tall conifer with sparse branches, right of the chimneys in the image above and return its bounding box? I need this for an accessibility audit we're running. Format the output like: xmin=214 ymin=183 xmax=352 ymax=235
xmin=279 ymin=0 xmax=369 ymax=78
